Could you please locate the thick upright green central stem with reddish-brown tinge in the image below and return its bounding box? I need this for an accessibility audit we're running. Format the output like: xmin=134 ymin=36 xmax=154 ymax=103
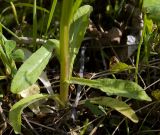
xmin=60 ymin=0 xmax=73 ymax=104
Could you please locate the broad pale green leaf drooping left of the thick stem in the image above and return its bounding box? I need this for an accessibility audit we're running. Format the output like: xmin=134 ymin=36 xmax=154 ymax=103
xmin=11 ymin=40 xmax=57 ymax=93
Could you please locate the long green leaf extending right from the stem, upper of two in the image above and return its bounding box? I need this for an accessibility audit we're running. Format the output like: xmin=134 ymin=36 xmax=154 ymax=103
xmin=70 ymin=77 xmax=151 ymax=101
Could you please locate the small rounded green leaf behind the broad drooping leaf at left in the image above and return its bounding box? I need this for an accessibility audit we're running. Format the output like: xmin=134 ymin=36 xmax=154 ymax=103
xmin=11 ymin=49 xmax=25 ymax=62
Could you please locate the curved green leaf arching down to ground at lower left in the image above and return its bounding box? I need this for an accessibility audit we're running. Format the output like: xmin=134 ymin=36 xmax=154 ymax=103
xmin=9 ymin=94 xmax=49 ymax=134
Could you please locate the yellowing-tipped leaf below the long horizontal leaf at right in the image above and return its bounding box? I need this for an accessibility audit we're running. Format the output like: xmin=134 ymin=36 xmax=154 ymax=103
xmin=89 ymin=97 xmax=138 ymax=123
